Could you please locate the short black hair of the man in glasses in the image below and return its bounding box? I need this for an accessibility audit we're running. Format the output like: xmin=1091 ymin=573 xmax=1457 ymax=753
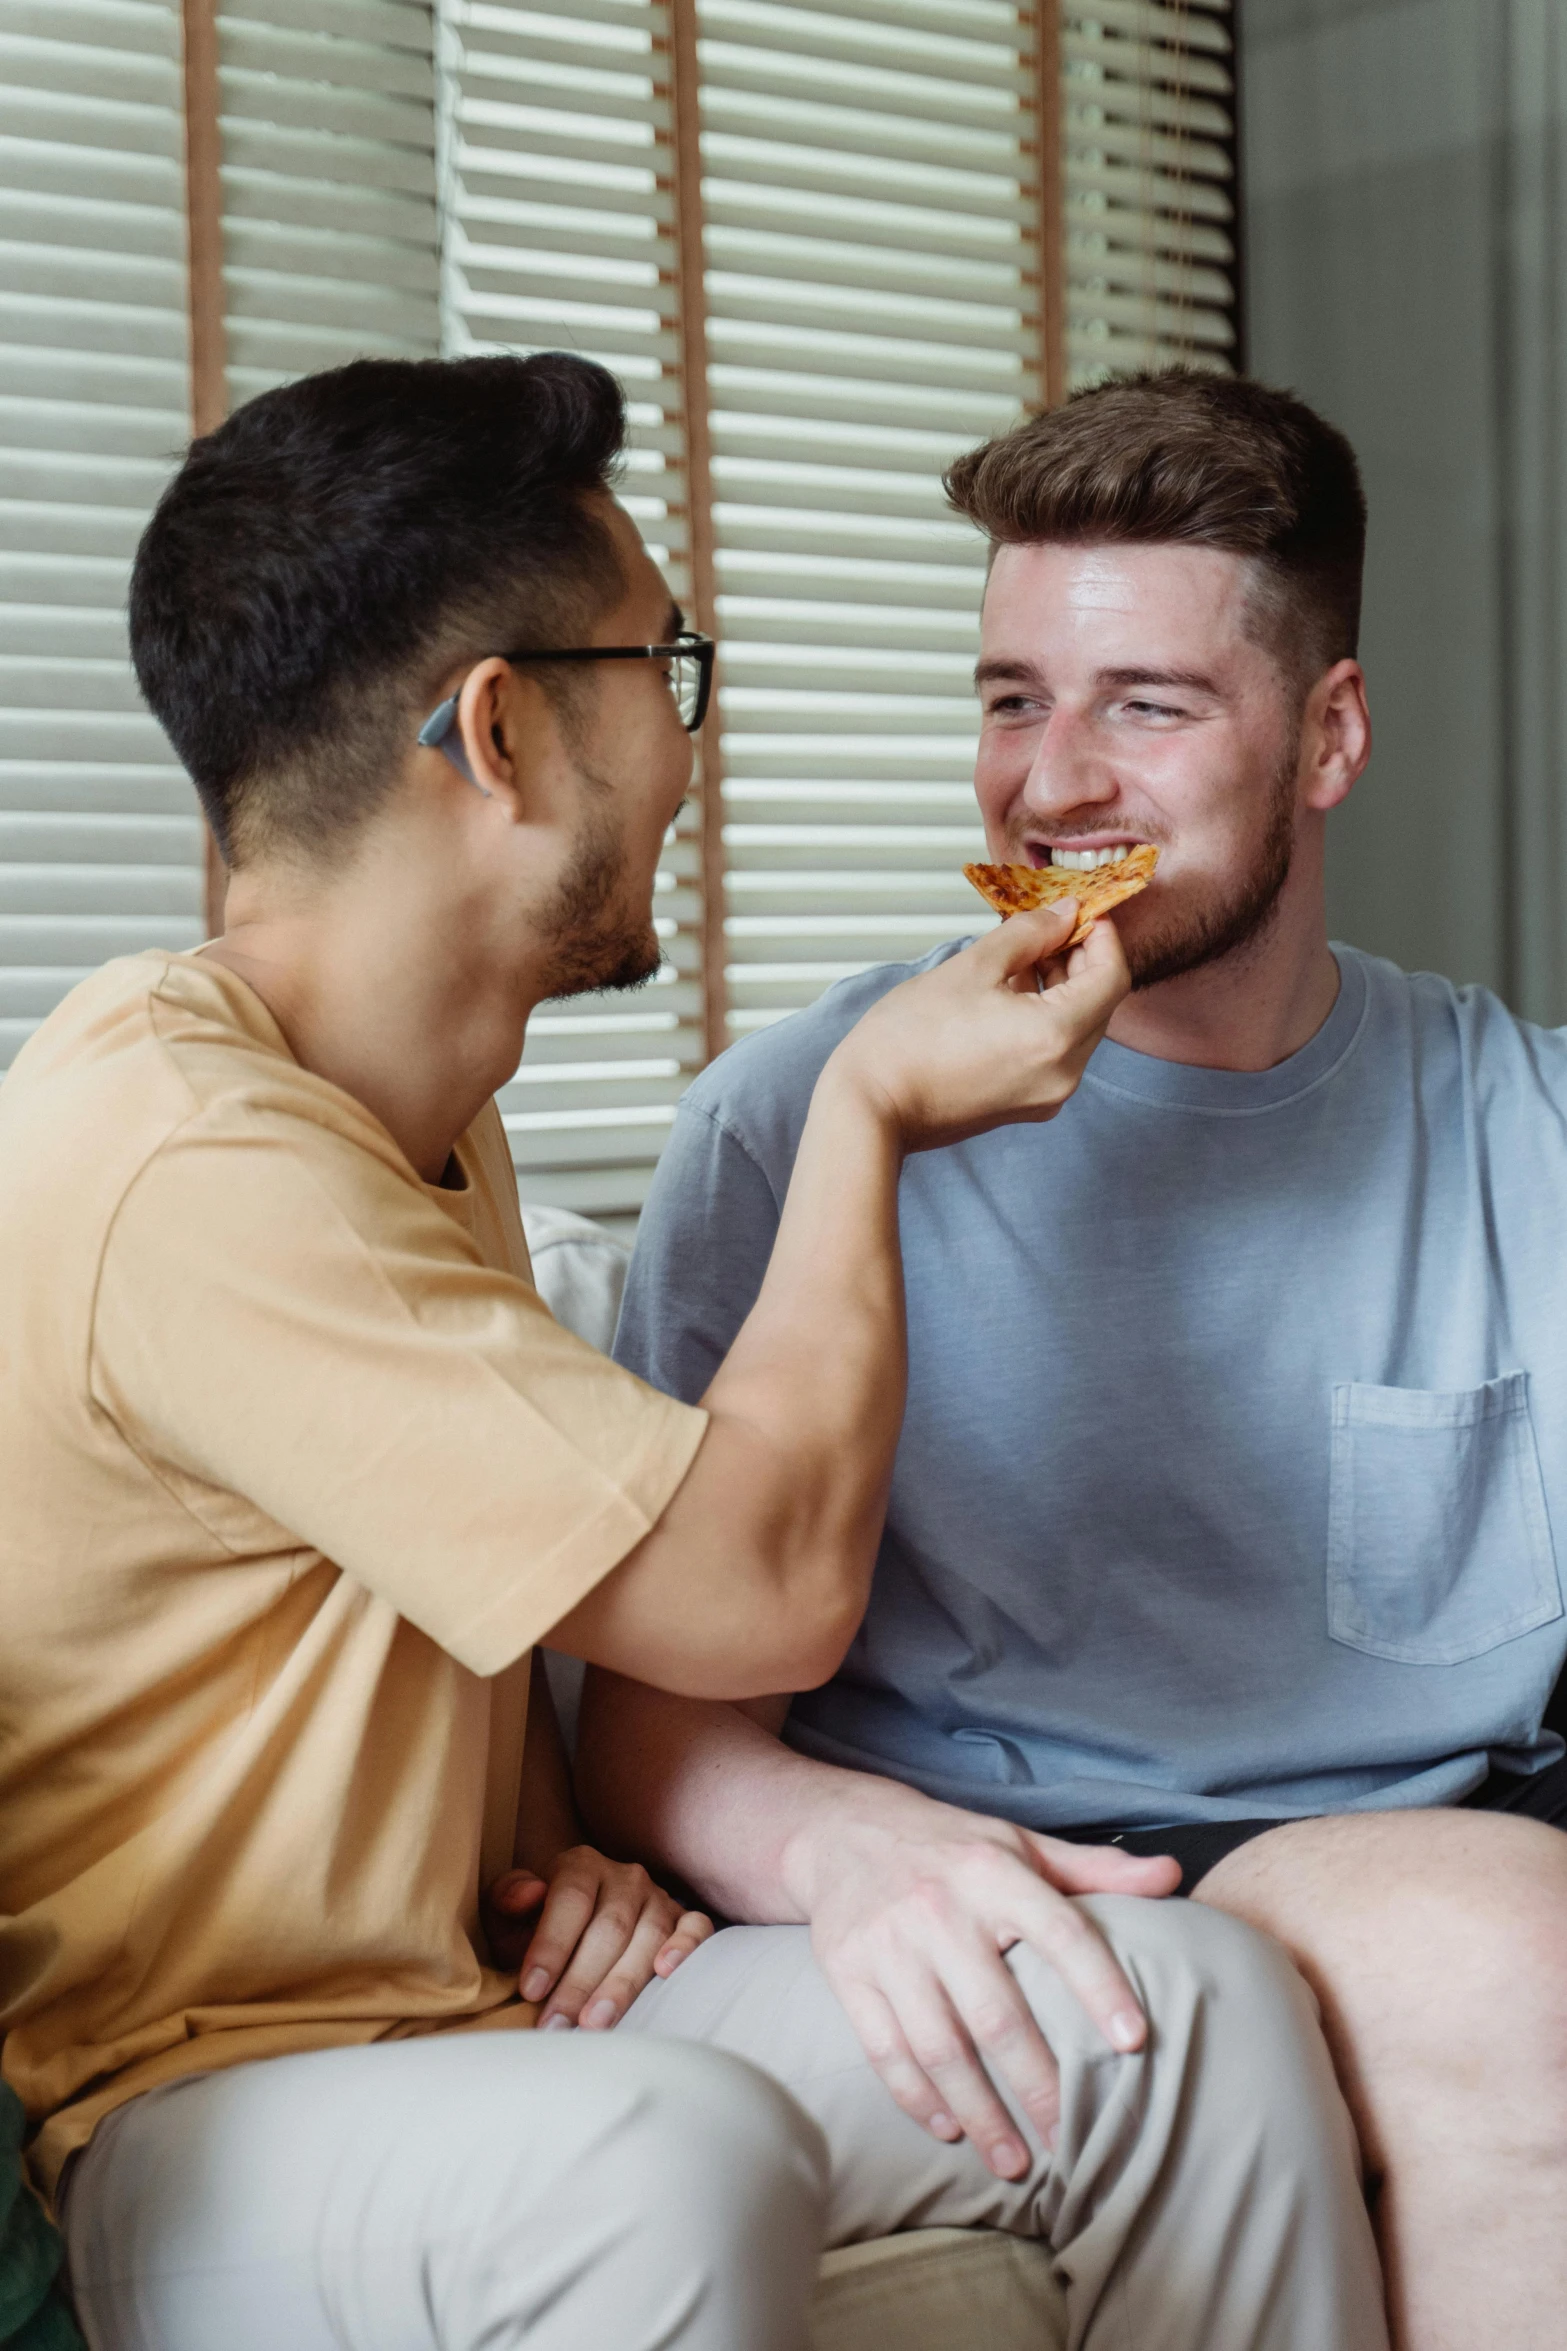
xmin=129 ymin=353 xmax=625 ymax=863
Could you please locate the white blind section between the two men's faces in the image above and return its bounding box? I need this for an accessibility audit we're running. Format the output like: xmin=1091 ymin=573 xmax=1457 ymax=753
xmin=698 ymin=0 xmax=1041 ymax=1032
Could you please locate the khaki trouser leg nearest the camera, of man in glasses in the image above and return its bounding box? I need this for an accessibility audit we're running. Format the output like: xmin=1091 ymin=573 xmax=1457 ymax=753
xmin=63 ymin=2031 xmax=827 ymax=2351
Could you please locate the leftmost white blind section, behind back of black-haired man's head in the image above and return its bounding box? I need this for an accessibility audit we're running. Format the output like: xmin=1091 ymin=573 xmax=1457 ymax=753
xmin=0 ymin=0 xmax=202 ymax=1070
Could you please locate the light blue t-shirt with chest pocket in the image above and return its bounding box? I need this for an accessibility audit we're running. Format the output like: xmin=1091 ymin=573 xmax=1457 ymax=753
xmin=616 ymin=947 xmax=1567 ymax=1829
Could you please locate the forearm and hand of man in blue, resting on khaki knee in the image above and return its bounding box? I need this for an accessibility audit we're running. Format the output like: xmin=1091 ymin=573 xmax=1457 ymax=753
xmin=578 ymin=1674 xmax=1179 ymax=2177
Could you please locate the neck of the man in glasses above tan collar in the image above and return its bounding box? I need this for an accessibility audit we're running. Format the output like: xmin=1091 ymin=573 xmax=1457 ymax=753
xmin=207 ymin=846 xmax=543 ymax=1183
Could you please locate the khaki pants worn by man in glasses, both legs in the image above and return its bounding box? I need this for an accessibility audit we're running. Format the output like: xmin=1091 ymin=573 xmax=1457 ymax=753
xmin=63 ymin=1897 xmax=1386 ymax=2351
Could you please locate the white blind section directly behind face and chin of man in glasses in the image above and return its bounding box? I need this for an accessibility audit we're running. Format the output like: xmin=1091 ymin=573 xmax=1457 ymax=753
xmin=444 ymin=0 xmax=702 ymax=1225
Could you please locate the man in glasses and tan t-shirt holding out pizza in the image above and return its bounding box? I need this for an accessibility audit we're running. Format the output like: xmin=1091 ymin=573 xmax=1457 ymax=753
xmin=0 ymin=357 xmax=1379 ymax=2351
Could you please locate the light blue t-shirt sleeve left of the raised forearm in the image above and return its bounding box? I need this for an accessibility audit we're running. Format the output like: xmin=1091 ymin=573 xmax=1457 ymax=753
xmin=616 ymin=1103 xmax=782 ymax=1404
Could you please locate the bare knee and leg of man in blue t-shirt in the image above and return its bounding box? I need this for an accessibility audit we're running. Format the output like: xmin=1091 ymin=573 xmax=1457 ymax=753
xmin=1198 ymin=1810 xmax=1567 ymax=2351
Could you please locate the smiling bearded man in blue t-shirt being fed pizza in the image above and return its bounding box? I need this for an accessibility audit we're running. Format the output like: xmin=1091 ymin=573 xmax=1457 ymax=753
xmin=585 ymin=374 xmax=1567 ymax=2351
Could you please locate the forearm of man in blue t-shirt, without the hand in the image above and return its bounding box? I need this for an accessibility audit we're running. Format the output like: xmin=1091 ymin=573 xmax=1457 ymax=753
xmin=576 ymin=1669 xmax=928 ymax=1925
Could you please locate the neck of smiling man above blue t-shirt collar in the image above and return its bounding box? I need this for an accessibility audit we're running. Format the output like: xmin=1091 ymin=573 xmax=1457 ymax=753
xmin=1109 ymin=844 xmax=1339 ymax=1070
